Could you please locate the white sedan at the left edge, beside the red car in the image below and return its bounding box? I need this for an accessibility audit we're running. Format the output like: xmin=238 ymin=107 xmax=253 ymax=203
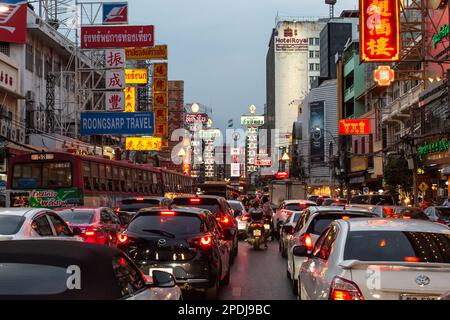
xmin=0 ymin=208 xmax=82 ymax=241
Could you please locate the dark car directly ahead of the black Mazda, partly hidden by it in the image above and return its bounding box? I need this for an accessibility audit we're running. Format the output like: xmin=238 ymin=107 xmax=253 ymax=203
xmin=172 ymin=196 xmax=239 ymax=264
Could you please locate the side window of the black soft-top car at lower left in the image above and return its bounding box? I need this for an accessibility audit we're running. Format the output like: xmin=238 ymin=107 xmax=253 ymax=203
xmin=112 ymin=255 xmax=146 ymax=297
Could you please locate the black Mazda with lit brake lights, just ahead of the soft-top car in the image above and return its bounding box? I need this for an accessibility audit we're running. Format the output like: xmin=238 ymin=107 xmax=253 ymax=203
xmin=118 ymin=208 xmax=231 ymax=299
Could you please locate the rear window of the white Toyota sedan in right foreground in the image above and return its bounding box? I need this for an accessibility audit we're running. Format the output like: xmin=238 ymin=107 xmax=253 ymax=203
xmin=344 ymin=231 xmax=450 ymax=263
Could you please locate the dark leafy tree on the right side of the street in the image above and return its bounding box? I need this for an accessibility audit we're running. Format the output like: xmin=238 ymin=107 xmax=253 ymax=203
xmin=384 ymin=158 xmax=413 ymax=193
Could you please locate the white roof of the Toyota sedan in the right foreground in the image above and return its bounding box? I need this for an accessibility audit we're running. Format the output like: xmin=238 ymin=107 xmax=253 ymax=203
xmin=340 ymin=218 xmax=450 ymax=235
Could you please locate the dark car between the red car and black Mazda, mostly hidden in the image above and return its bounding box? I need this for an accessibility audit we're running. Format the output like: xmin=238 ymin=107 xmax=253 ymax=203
xmin=115 ymin=197 xmax=172 ymax=225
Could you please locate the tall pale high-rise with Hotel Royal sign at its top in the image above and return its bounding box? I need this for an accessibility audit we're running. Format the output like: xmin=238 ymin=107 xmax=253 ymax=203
xmin=264 ymin=18 xmax=326 ymax=152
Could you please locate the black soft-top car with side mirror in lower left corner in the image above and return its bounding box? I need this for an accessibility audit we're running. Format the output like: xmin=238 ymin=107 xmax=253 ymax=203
xmin=0 ymin=240 xmax=179 ymax=300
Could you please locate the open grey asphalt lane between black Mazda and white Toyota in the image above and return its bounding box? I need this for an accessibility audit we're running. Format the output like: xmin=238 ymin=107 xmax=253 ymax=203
xmin=220 ymin=241 xmax=296 ymax=300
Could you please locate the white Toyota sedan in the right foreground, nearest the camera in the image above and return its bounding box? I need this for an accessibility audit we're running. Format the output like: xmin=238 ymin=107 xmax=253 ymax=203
xmin=294 ymin=219 xmax=450 ymax=300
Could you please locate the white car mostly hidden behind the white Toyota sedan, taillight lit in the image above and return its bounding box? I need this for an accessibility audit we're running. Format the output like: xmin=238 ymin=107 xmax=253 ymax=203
xmin=286 ymin=206 xmax=375 ymax=294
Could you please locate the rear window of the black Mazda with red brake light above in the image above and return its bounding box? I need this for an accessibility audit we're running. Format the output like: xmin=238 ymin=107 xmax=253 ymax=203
xmin=128 ymin=213 xmax=202 ymax=235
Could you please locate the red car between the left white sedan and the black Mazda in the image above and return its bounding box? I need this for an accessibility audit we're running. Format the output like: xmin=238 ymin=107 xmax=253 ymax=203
xmin=58 ymin=207 xmax=123 ymax=247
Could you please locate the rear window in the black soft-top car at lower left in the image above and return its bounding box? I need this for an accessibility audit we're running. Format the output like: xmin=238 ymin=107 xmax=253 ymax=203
xmin=0 ymin=262 xmax=68 ymax=296
